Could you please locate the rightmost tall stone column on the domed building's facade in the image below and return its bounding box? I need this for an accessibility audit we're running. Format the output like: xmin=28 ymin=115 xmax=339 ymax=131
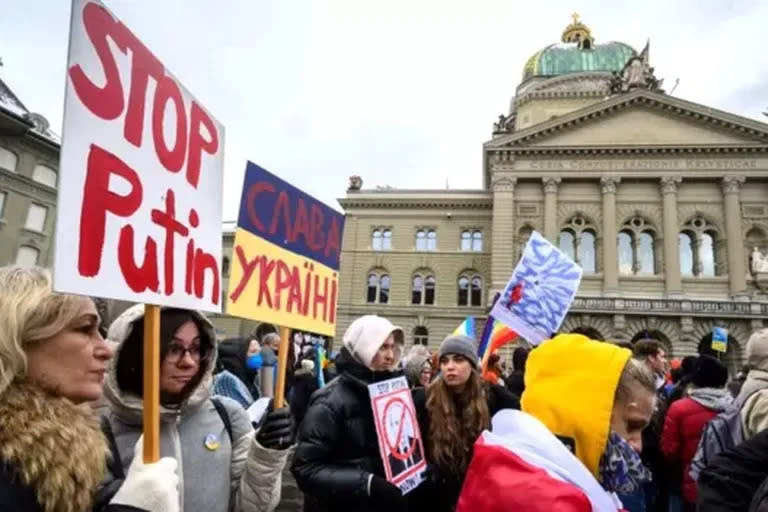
xmin=722 ymin=176 xmax=747 ymax=295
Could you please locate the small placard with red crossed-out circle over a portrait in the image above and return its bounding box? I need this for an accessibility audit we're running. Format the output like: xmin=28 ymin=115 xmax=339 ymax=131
xmin=368 ymin=377 xmax=427 ymax=494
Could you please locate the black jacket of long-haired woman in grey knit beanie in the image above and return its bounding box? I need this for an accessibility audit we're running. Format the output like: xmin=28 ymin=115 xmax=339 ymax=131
xmin=408 ymin=383 xmax=520 ymax=512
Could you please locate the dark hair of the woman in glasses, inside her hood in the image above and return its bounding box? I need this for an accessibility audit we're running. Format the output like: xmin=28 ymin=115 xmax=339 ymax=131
xmin=116 ymin=309 xmax=213 ymax=403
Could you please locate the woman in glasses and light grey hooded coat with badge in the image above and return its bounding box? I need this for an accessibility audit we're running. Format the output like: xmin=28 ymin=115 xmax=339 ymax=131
xmin=104 ymin=305 xmax=293 ymax=512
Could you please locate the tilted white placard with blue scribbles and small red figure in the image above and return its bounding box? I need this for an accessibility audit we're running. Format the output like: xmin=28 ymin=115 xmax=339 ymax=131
xmin=491 ymin=231 xmax=582 ymax=345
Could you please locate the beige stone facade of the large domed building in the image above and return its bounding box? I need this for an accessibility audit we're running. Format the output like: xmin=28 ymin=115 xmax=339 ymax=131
xmin=337 ymin=88 xmax=768 ymax=368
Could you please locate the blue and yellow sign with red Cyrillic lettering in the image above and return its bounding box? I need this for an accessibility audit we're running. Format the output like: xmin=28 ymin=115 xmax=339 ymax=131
xmin=227 ymin=162 xmax=344 ymax=336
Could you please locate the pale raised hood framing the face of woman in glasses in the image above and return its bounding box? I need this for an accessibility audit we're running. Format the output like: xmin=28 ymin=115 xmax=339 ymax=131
xmin=104 ymin=304 xmax=217 ymax=425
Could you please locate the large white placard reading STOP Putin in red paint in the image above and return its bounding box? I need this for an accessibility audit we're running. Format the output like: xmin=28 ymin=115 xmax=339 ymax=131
xmin=54 ymin=0 xmax=224 ymax=312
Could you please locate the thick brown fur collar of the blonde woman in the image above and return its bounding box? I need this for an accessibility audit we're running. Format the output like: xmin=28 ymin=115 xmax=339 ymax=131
xmin=0 ymin=381 xmax=109 ymax=512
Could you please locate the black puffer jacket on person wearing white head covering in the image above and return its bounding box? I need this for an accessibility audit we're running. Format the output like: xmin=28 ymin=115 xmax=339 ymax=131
xmin=291 ymin=348 xmax=401 ymax=512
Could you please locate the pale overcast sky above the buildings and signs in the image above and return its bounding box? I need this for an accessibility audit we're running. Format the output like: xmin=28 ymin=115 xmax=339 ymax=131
xmin=0 ymin=0 xmax=768 ymax=219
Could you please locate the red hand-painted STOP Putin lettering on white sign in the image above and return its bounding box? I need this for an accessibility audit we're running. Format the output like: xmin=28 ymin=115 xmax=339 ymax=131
xmin=68 ymin=3 xmax=221 ymax=304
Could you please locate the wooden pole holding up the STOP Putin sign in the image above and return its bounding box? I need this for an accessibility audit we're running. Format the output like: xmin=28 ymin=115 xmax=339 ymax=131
xmin=143 ymin=304 xmax=160 ymax=464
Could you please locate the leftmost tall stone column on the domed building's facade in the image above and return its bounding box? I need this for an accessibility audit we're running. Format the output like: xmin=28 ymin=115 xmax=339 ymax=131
xmin=490 ymin=177 xmax=517 ymax=292
